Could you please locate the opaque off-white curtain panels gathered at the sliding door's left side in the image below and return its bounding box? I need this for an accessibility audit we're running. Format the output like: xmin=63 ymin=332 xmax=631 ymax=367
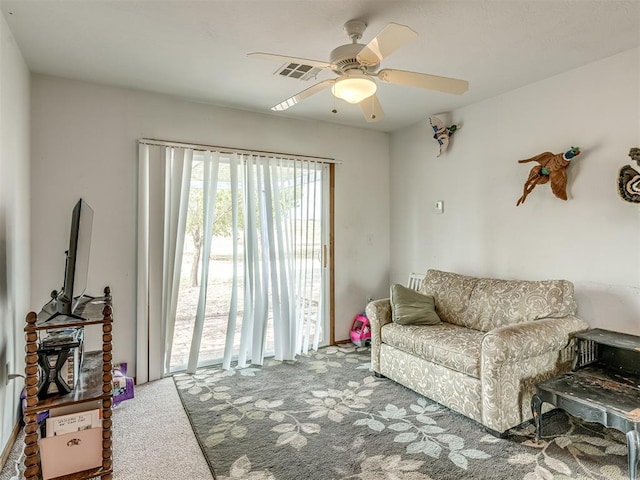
xmin=136 ymin=144 xmax=193 ymax=383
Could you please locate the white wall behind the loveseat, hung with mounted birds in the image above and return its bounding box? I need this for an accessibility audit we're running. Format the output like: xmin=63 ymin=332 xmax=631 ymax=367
xmin=390 ymin=49 xmax=640 ymax=334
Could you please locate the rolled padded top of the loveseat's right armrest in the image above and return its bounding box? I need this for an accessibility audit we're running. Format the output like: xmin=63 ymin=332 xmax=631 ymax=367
xmin=482 ymin=315 xmax=589 ymax=364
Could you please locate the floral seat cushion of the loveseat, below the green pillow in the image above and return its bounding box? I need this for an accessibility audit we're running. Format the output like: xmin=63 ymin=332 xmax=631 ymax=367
xmin=381 ymin=322 xmax=484 ymax=378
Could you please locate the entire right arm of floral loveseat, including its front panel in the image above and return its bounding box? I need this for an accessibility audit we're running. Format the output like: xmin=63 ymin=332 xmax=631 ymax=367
xmin=480 ymin=315 xmax=589 ymax=433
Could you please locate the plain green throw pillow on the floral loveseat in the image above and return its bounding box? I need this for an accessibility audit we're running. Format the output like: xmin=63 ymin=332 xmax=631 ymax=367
xmin=391 ymin=283 xmax=440 ymax=325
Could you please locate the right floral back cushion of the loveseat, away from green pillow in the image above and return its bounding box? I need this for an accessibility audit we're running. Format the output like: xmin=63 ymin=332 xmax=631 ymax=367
xmin=465 ymin=278 xmax=577 ymax=332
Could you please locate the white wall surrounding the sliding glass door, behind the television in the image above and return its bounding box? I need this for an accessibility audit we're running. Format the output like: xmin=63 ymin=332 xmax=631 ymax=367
xmin=31 ymin=75 xmax=389 ymax=376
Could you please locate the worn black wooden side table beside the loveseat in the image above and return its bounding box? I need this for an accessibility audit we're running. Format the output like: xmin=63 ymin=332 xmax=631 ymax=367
xmin=531 ymin=329 xmax=640 ymax=480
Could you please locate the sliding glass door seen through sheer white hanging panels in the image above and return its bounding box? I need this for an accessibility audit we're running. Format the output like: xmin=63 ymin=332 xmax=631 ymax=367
xmin=170 ymin=152 xmax=332 ymax=371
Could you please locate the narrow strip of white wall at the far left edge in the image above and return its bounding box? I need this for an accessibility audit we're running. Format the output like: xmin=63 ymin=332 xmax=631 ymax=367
xmin=0 ymin=13 xmax=29 ymax=462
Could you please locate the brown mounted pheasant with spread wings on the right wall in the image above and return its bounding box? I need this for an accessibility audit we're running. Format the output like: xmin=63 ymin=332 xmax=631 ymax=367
xmin=516 ymin=147 xmax=580 ymax=206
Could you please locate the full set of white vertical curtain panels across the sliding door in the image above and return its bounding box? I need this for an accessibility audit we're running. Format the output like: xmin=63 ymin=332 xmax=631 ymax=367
xmin=137 ymin=143 xmax=328 ymax=382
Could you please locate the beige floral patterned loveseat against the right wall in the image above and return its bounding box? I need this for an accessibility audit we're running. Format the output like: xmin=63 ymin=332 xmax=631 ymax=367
xmin=366 ymin=270 xmax=589 ymax=435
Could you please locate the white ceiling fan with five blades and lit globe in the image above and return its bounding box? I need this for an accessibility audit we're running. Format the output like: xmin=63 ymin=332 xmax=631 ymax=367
xmin=248 ymin=20 xmax=469 ymax=122
